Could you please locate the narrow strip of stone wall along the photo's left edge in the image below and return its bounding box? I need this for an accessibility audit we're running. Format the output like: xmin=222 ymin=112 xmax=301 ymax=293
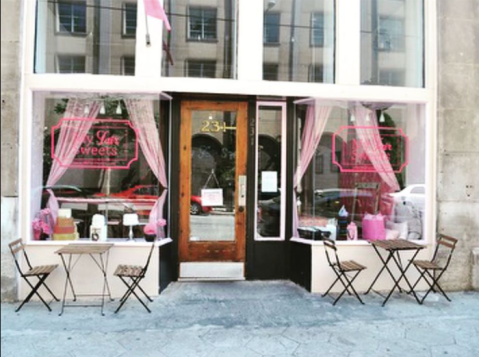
xmin=1 ymin=0 xmax=23 ymax=301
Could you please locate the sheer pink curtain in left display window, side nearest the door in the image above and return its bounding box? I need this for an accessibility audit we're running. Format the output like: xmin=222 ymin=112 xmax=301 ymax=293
xmin=125 ymin=99 xmax=168 ymax=237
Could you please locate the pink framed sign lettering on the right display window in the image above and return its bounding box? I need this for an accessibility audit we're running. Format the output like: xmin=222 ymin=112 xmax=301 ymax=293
xmin=332 ymin=126 xmax=409 ymax=173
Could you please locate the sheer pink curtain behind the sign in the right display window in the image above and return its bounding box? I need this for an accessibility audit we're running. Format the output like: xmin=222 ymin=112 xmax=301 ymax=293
xmin=352 ymin=107 xmax=400 ymax=192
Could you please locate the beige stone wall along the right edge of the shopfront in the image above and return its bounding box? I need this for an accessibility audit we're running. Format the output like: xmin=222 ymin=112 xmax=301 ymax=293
xmin=437 ymin=0 xmax=479 ymax=290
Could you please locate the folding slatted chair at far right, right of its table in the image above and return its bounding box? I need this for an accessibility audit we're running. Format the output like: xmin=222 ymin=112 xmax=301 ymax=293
xmin=411 ymin=234 xmax=457 ymax=304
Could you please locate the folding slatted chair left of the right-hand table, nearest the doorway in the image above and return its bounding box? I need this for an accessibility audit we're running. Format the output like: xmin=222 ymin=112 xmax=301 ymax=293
xmin=322 ymin=239 xmax=366 ymax=306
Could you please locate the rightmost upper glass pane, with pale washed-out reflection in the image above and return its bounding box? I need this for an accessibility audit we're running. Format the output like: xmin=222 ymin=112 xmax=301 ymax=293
xmin=361 ymin=0 xmax=424 ymax=87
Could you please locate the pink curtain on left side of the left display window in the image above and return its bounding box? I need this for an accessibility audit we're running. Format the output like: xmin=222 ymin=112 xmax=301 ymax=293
xmin=47 ymin=98 xmax=100 ymax=224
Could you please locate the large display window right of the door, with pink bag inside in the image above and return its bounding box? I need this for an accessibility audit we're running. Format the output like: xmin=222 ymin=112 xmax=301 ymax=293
xmin=293 ymin=100 xmax=427 ymax=240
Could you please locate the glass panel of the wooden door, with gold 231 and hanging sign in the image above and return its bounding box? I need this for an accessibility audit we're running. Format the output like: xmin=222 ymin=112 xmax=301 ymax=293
xmin=190 ymin=110 xmax=237 ymax=241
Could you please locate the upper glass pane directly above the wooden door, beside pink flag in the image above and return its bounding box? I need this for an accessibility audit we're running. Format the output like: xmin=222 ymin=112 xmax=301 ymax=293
xmin=162 ymin=0 xmax=237 ymax=78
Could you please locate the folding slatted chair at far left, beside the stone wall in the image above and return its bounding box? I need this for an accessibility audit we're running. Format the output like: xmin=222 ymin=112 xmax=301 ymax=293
xmin=8 ymin=239 xmax=60 ymax=312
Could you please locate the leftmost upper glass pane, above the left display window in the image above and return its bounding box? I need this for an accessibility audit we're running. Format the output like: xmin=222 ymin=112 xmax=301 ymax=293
xmin=35 ymin=0 xmax=137 ymax=75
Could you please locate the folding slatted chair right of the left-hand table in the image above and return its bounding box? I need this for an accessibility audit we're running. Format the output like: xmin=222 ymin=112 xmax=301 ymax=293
xmin=113 ymin=242 xmax=155 ymax=314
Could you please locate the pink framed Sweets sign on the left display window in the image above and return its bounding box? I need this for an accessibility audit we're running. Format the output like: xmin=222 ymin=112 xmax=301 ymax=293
xmin=52 ymin=118 xmax=138 ymax=170
